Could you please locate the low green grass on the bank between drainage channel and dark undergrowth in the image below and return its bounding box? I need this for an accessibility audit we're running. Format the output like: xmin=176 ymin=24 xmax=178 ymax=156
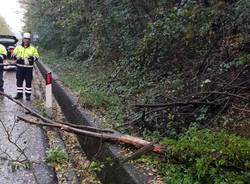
xmin=42 ymin=52 xmax=149 ymax=127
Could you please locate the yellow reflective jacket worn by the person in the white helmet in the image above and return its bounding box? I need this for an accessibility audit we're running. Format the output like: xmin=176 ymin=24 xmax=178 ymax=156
xmin=13 ymin=45 xmax=39 ymax=68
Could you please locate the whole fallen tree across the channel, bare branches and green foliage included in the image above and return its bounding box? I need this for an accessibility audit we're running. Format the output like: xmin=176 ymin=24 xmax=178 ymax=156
xmin=0 ymin=92 xmax=250 ymax=175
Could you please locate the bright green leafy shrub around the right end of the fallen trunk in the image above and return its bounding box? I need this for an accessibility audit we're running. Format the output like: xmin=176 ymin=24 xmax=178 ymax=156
xmin=141 ymin=127 xmax=250 ymax=184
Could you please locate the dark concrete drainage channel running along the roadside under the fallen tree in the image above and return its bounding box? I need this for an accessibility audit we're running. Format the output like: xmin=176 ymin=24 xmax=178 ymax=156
xmin=37 ymin=62 xmax=148 ymax=184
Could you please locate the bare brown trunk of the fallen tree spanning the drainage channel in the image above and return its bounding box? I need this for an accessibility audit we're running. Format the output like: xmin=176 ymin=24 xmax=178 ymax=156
xmin=17 ymin=116 xmax=249 ymax=171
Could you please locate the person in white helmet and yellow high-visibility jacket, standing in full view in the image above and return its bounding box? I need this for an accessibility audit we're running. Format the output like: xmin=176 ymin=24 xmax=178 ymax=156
xmin=13 ymin=33 xmax=39 ymax=100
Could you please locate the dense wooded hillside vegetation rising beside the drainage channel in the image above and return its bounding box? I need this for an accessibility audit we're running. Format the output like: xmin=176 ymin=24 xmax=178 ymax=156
xmin=21 ymin=0 xmax=250 ymax=183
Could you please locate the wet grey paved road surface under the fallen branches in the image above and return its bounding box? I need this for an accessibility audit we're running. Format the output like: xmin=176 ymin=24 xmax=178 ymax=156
xmin=0 ymin=71 xmax=57 ymax=184
